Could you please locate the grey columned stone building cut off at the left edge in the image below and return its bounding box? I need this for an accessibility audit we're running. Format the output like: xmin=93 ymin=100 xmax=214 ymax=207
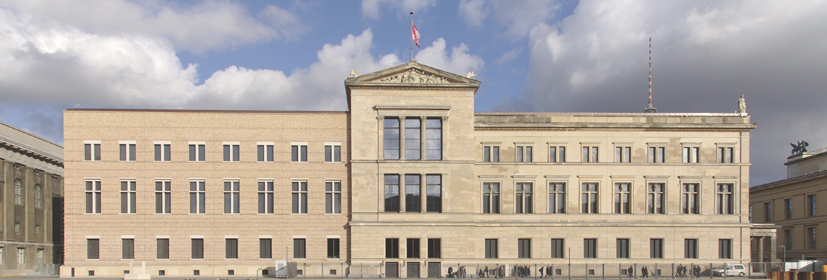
xmin=0 ymin=122 xmax=63 ymax=275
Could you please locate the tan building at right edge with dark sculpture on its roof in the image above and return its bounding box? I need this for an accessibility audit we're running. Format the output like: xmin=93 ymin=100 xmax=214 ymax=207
xmin=749 ymin=145 xmax=827 ymax=261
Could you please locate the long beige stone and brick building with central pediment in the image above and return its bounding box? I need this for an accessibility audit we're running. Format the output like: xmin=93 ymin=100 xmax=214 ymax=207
xmin=61 ymin=62 xmax=755 ymax=277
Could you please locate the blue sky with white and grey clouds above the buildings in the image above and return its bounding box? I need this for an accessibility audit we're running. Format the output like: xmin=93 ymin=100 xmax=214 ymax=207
xmin=0 ymin=0 xmax=827 ymax=185
